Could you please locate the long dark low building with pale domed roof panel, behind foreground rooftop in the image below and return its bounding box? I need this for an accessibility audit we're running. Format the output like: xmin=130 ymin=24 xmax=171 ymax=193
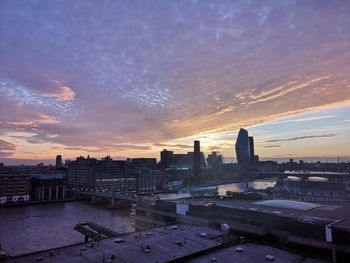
xmin=135 ymin=197 xmax=350 ymax=262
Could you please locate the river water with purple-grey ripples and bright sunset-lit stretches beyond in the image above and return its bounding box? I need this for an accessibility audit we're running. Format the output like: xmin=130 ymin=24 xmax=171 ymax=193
xmin=0 ymin=180 xmax=275 ymax=255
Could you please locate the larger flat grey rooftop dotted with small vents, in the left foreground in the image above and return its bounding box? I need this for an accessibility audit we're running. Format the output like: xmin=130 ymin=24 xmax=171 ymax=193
xmin=8 ymin=225 xmax=222 ymax=263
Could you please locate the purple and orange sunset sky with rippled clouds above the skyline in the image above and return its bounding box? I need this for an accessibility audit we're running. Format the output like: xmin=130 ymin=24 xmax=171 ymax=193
xmin=0 ymin=0 xmax=350 ymax=164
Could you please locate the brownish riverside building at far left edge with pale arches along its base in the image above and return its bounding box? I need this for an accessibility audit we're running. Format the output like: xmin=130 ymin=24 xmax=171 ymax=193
xmin=0 ymin=173 xmax=30 ymax=205
